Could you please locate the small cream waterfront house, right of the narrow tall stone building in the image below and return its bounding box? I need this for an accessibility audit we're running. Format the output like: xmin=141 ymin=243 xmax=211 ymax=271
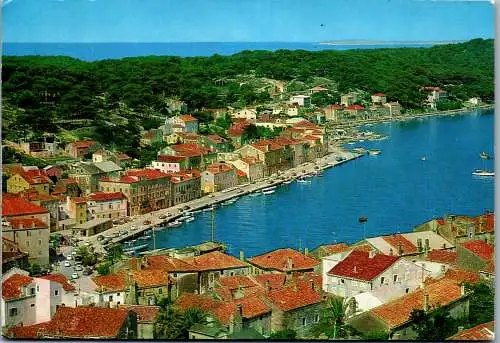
xmin=201 ymin=163 xmax=238 ymax=193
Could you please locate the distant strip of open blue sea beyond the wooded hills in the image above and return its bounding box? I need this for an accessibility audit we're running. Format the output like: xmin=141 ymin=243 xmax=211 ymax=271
xmin=2 ymin=42 xmax=432 ymax=61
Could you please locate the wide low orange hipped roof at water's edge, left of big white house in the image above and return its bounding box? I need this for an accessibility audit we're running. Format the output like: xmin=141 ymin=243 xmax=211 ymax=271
xmin=248 ymin=248 xmax=320 ymax=271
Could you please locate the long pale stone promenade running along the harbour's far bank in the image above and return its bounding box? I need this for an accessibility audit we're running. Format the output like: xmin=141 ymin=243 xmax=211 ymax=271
xmin=79 ymin=146 xmax=363 ymax=254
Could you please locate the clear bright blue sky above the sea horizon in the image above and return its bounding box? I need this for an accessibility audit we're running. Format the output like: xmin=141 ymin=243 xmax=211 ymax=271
xmin=2 ymin=0 xmax=494 ymax=42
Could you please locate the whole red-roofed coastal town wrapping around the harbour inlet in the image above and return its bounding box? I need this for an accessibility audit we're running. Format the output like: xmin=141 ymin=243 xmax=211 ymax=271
xmin=1 ymin=81 xmax=495 ymax=340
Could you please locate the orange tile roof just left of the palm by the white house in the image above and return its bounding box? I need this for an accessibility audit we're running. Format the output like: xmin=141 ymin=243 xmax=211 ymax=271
xmin=268 ymin=283 xmax=322 ymax=312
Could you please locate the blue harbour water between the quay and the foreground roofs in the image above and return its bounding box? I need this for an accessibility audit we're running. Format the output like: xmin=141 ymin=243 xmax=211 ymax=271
xmin=144 ymin=111 xmax=494 ymax=256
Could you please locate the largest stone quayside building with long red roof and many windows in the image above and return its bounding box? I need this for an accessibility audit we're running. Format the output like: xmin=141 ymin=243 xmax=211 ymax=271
xmin=99 ymin=169 xmax=171 ymax=216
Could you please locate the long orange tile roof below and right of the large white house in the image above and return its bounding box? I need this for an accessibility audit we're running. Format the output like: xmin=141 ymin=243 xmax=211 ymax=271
xmin=370 ymin=278 xmax=462 ymax=329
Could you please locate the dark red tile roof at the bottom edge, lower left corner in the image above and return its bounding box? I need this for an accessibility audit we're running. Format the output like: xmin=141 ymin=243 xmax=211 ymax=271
xmin=46 ymin=307 xmax=129 ymax=338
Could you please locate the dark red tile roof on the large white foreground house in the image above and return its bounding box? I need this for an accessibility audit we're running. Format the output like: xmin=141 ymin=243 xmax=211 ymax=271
xmin=328 ymin=250 xmax=399 ymax=281
